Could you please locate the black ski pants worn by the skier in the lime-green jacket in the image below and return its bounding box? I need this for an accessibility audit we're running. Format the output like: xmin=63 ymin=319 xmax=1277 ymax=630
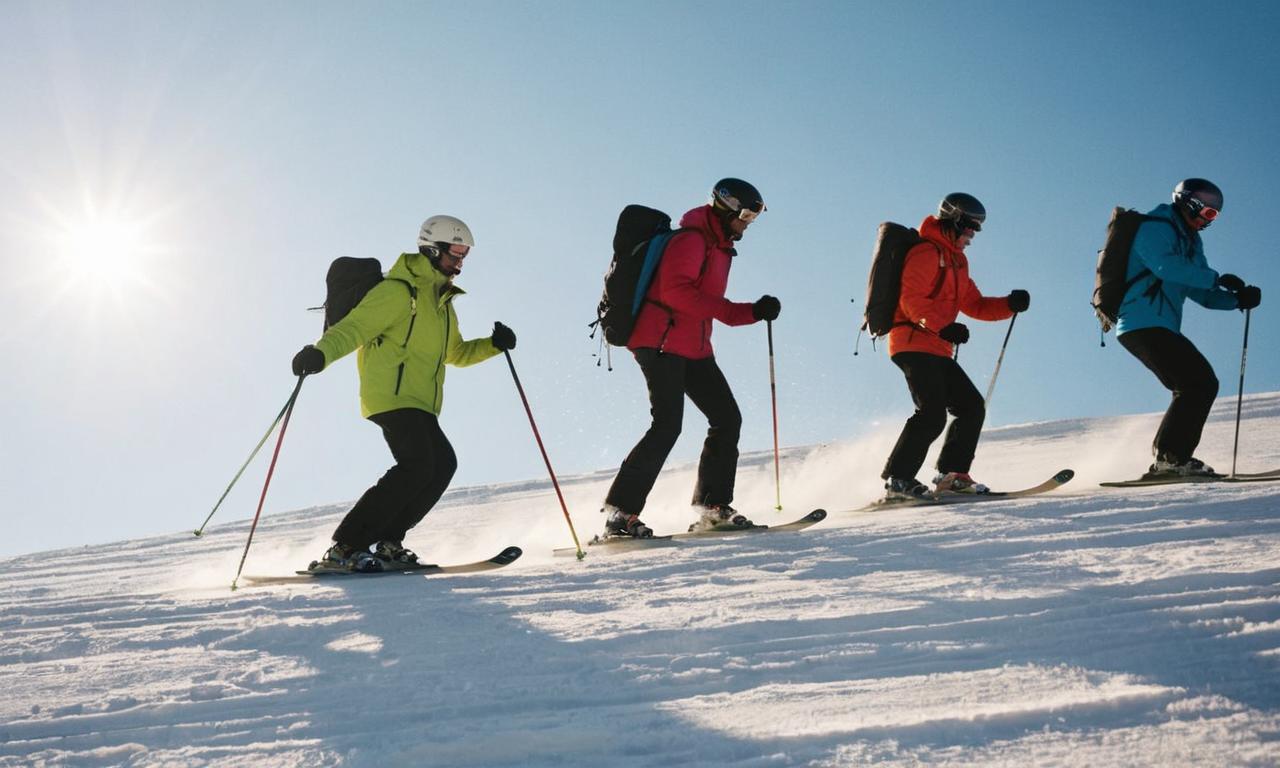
xmin=333 ymin=408 xmax=458 ymax=549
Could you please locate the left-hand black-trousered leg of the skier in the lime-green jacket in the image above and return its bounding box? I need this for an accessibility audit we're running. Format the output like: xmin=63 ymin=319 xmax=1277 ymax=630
xmin=333 ymin=408 xmax=435 ymax=549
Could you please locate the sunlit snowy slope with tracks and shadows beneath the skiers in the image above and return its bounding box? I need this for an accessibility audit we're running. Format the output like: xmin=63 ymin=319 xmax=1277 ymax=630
xmin=0 ymin=393 xmax=1280 ymax=768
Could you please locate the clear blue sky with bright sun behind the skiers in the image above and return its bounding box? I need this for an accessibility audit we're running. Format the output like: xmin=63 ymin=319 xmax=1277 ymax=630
xmin=0 ymin=1 xmax=1280 ymax=554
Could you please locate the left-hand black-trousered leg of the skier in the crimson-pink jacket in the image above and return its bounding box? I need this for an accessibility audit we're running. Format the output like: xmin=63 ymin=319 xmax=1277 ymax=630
xmin=604 ymin=349 xmax=689 ymax=515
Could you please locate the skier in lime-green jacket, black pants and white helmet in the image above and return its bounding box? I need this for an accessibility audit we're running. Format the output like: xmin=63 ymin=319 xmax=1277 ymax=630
xmin=293 ymin=216 xmax=516 ymax=571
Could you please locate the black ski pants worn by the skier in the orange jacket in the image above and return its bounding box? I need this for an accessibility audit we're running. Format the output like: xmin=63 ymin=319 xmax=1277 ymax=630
xmin=881 ymin=352 xmax=987 ymax=480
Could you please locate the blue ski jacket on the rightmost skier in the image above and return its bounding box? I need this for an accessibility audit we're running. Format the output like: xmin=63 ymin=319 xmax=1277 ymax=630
xmin=1116 ymin=202 xmax=1239 ymax=335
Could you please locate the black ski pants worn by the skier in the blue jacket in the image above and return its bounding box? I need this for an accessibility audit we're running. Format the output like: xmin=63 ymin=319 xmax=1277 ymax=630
xmin=1120 ymin=328 xmax=1217 ymax=463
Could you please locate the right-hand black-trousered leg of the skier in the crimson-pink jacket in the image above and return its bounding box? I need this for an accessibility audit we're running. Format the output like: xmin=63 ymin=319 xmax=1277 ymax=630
xmin=685 ymin=357 xmax=742 ymax=507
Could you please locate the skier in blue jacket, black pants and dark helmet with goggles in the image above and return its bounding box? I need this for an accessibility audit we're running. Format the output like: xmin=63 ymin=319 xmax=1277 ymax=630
xmin=1116 ymin=179 xmax=1262 ymax=477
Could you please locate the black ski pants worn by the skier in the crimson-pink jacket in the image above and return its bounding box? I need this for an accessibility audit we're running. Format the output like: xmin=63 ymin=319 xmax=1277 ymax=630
xmin=605 ymin=349 xmax=742 ymax=515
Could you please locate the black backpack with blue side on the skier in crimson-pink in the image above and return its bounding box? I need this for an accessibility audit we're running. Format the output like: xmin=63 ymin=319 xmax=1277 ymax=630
xmin=591 ymin=205 xmax=686 ymax=347
